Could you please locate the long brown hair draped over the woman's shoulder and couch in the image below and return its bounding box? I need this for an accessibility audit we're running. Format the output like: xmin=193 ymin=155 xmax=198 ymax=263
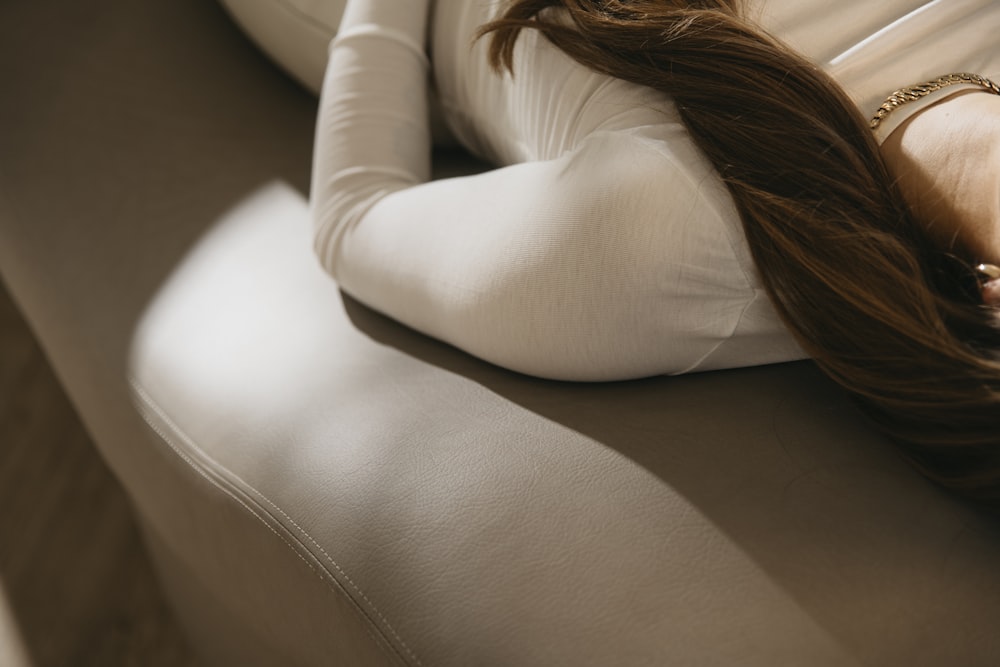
xmin=480 ymin=0 xmax=1000 ymax=508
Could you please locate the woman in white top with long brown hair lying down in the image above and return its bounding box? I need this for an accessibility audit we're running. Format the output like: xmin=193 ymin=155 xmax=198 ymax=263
xmin=313 ymin=0 xmax=1000 ymax=507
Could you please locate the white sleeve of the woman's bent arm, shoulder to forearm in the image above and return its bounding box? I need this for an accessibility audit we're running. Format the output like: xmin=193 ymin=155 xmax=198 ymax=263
xmin=313 ymin=0 xmax=768 ymax=380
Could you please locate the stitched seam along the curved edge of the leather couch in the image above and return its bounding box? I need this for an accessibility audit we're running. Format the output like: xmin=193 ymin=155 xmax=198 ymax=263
xmin=129 ymin=379 xmax=423 ymax=667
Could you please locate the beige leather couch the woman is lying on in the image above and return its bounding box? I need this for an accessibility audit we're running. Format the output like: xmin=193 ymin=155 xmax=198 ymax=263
xmin=0 ymin=0 xmax=1000 ymax=667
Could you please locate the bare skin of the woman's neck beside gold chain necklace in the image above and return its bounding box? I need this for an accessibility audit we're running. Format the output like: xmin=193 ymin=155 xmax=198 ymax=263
xmin=882 ymin=91 xmax=1000 ymax=264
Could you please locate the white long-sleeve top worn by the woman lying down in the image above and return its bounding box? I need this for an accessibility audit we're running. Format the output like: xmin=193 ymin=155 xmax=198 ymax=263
xmin=312 ymin=0 xmax=1000 ymax=380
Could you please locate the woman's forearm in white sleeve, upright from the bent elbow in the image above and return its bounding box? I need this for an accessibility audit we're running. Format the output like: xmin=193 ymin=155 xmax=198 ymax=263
xmin=311 ymin=0 xmax=431 ymax=274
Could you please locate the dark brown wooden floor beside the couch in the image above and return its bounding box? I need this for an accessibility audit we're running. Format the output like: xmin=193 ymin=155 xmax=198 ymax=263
xmin=0 ymin=285 xmax=196 ymax=667
